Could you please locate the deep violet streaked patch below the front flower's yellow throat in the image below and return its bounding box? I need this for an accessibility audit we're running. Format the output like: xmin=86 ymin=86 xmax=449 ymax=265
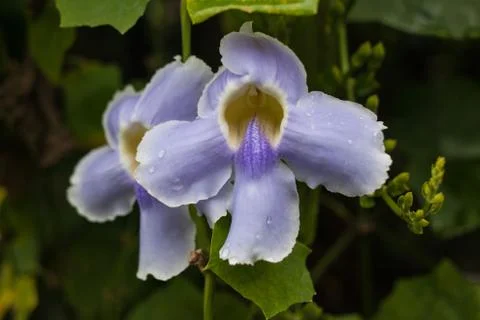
xmin=235 ymin=119 xmax=278 ymax=179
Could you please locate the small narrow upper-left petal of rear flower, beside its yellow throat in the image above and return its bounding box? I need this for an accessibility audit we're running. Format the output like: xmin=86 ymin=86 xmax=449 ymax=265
xmin=102 ymin=86 xmax=140 ymax=149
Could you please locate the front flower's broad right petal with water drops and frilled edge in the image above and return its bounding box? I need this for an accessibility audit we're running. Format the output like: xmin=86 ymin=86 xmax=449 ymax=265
xmin=279 ymin=92 xmax=392 ymax=196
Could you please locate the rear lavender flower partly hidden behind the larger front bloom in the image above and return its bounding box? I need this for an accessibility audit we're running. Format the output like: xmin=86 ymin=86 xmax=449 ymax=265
xmin=67 ymin=57 xmax=229 ymax=280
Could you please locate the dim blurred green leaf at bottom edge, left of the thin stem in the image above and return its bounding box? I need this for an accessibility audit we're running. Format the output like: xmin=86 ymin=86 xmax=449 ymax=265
xmin=127 ymin=278 xmax=202 ymax=320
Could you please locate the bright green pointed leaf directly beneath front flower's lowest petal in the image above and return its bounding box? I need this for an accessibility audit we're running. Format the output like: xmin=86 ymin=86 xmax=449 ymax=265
xmin=207 ymin=218 xmax=315 ymax=318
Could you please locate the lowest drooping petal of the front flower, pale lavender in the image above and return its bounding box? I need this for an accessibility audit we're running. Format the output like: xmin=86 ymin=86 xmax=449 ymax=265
xmin=220 ymin=161 xmax=300 ymax=265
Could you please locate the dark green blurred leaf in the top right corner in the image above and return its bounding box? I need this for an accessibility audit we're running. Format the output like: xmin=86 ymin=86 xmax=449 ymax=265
xmin=349 ymin=0 xmax=480 ymax=39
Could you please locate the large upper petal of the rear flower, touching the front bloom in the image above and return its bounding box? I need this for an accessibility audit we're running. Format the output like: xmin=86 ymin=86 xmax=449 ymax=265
xmin=133 ymin=56 xmax=213 ymax=127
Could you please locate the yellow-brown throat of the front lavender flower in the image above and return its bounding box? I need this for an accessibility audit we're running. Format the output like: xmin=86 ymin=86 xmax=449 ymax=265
xmin=220 ymin=84 xmax=285 ymax=150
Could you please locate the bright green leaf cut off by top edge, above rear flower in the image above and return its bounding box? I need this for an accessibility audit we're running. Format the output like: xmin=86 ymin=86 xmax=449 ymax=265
xmin=56 ymin=0 xmax=149 ymax=33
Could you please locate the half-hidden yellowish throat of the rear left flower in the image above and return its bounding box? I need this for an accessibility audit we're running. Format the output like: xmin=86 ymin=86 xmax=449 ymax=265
xmin=118 ymin=122 xmax=148 ymax=175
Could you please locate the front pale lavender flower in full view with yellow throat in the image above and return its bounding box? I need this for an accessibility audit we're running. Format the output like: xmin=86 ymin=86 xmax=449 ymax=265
xmin=135 ymin=23 xmax=391 ymax=264
